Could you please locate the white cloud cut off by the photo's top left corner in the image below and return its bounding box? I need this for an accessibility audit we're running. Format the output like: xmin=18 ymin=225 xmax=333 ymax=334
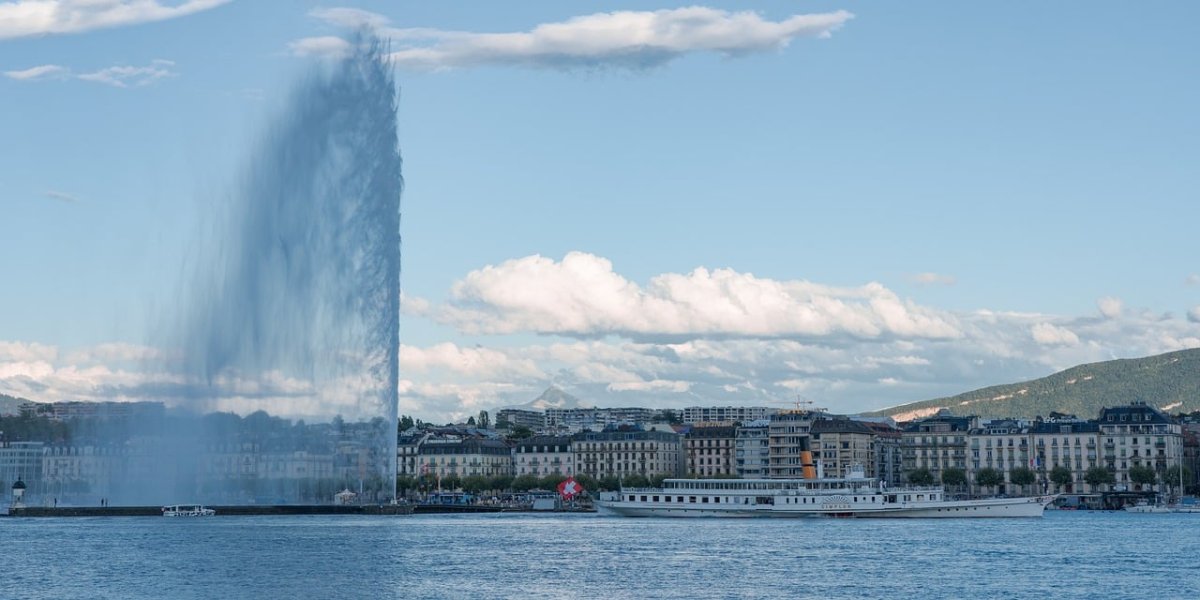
xmin=0 ymin=0 xmax=229 ymax=40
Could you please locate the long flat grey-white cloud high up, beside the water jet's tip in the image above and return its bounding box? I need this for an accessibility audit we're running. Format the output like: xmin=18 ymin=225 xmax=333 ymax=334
xmin=298 ymin=6 xmax=853 ymax=71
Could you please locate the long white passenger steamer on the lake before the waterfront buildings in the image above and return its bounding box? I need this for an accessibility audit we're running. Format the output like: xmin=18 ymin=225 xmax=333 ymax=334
xmin=596 ymin=468 xmax=1055 ymax=518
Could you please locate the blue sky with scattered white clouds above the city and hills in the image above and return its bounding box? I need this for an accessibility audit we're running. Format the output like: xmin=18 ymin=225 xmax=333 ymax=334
xmin=0 ymin=0 xmax=1200 ymax=421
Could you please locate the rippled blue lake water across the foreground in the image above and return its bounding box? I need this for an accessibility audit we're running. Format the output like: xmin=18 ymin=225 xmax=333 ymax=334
xmin=0 ymin=511 xmax=1200 ymax=600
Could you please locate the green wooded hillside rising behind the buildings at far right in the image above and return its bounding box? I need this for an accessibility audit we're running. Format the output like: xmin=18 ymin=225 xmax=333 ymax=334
xmin=866 ymin=348 xmax=1200 ymax=421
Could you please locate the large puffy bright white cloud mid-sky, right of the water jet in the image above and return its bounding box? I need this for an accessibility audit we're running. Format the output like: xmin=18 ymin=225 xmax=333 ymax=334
xmin=438 ymin=252 xmax=961 ymax=338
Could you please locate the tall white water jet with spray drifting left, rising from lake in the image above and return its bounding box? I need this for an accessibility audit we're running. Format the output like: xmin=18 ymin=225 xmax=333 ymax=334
xmin=147 ymin=35 xmax=403 ymax=500
